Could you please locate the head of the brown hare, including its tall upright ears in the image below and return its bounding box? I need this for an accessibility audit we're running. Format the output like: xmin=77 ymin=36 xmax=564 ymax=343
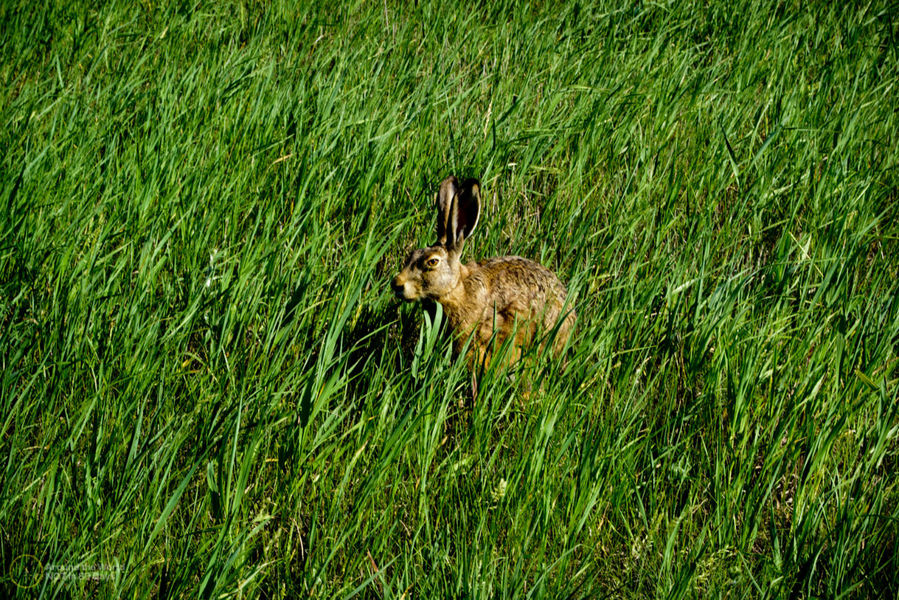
xmin=391 ymin=176 xmax=481 ymax=302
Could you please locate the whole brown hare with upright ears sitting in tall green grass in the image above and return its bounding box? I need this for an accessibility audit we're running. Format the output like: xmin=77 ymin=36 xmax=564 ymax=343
xmin=391 ymin=176 xmax=575 ymax=384
